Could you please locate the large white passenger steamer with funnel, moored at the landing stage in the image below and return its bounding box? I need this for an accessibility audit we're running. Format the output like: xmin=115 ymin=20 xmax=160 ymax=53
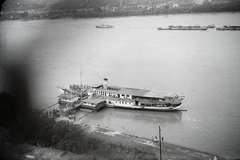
xmin=88 ymin=78 xmax=184 ymax=111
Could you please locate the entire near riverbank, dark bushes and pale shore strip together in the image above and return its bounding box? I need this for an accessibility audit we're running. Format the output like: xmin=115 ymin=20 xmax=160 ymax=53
xmin=0 ymin=90 xmax=228 ymax=160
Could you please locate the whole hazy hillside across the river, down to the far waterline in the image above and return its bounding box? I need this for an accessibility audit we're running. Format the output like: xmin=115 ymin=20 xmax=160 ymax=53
xmin=1 ymin=0 xmax=240 ymax=20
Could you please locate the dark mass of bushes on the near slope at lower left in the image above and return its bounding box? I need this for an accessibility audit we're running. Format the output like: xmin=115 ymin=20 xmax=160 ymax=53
xmin=0 ymin=93 xmax=156 ymax=160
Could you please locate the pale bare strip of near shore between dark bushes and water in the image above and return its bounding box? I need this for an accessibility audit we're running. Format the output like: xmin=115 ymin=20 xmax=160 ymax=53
xmin=56 ymin=116 xmax=226 ymax=160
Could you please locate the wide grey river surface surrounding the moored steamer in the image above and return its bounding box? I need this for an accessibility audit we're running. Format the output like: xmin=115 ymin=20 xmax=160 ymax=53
xmin=0 ymin=13 xmax=240 ymax=158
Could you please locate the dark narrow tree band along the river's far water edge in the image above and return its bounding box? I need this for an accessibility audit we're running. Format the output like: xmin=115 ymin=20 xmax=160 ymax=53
xmin=0 ymin=8 xmax=240 ymax=21
